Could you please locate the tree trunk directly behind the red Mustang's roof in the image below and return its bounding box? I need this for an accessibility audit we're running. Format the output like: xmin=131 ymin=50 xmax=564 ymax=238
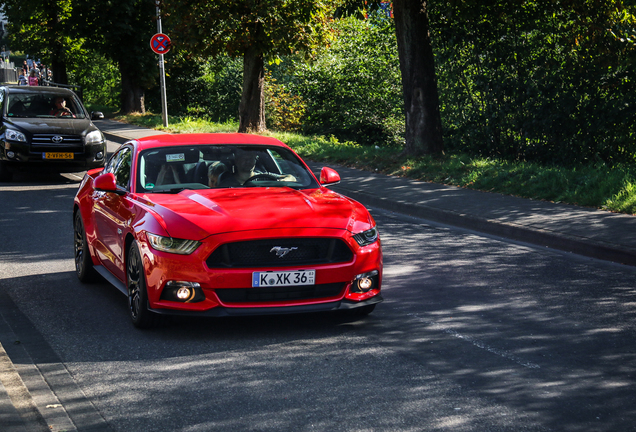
xmin=238 ymin=47 xmax=266 ymax=133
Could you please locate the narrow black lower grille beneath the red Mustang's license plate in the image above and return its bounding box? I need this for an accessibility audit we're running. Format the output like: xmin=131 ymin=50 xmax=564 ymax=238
xmin=215 ymin=282 xmax=345 ymax=303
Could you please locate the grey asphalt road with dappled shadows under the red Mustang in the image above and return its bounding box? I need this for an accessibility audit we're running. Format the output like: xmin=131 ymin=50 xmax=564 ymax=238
xmin=0 ymin=140 xmax=636 ymax=432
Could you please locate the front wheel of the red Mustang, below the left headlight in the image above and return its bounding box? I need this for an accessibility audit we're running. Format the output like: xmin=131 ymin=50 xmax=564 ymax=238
xmin=126 ymin=242 xmax=158 ymax=329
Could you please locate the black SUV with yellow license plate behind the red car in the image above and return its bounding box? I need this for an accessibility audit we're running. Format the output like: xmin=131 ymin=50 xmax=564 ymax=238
xmin=0 ymin=86 xmax=106 ymax=181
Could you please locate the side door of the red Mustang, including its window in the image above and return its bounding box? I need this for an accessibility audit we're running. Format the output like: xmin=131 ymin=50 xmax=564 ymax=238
xmin=94 ymin=146 xmax=133 ymax=281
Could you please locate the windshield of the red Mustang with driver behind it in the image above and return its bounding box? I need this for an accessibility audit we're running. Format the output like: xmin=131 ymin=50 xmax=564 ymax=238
xmin=137 ymin=145 xmax=319 ymax=193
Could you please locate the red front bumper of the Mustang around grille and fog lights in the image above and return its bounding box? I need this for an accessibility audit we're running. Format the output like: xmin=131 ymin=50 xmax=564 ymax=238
xmin=140 ymin=228 xmax=383 ymax=316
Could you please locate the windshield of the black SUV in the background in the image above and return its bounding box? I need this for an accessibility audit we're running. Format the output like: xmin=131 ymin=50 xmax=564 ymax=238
xmin=6 ymin=92 xmax=85 ymax=118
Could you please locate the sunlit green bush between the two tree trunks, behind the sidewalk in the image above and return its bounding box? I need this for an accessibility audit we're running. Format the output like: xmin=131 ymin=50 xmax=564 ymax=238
xmin=270 ymin=13 xmax=404 ymax=147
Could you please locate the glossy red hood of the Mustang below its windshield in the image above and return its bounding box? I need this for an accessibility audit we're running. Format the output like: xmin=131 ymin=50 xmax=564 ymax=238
xmin=139 ymin=187 xmax=373 ymax=240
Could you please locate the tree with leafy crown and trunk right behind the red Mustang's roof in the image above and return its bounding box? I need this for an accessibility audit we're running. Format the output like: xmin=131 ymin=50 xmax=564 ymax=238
xmin=163 ymin=0 xmax=332 ymax=131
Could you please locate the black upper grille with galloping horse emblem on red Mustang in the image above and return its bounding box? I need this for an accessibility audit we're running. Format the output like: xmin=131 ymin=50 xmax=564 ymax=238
xmin=206 ymin=238 xmax=353 ymax=268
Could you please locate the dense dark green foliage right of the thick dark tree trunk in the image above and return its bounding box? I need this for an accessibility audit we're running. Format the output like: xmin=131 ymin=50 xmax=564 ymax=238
xmin=431 ymin=0 xmax=636 ymax=164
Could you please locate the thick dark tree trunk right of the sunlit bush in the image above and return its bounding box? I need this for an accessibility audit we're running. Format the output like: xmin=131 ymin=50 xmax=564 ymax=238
xmin=393 ymin=0 xmax=444 ymax=156
